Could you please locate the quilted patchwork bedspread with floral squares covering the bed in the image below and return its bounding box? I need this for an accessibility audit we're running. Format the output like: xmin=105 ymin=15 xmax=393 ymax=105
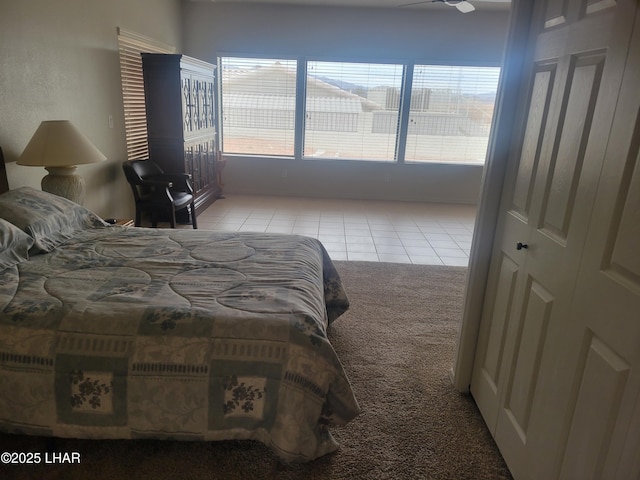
xmin=0 ymin=227 xmax=359 ymax=462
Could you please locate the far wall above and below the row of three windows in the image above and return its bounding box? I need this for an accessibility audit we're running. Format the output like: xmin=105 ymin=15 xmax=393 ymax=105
xmin=183 ymin=2 xmax=508 ymax=203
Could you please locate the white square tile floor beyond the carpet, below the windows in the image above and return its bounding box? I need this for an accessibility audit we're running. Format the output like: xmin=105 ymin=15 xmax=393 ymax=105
xmin=185 ymin=195 xmax=476 ymax=266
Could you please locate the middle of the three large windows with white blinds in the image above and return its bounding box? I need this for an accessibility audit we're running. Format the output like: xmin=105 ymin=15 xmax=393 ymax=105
xmin=304 ymin=62 xmax=403 ymax=161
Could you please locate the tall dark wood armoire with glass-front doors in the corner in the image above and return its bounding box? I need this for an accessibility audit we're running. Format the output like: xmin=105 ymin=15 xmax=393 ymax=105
xmin=142 ymin=53 xmax=222 ymax=222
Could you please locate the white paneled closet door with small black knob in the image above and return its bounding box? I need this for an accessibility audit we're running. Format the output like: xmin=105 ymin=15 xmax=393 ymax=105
xmin=471 ymin=0 xmax=640 ymax=480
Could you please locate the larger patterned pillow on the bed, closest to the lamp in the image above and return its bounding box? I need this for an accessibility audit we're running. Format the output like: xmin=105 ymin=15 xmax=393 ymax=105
xmin=0 ymin=187 xmax=106 ymax=253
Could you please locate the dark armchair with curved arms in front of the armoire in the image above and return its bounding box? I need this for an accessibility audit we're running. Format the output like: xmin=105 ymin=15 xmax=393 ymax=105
xmin=122 ymin=160 xmax=198 ymax=228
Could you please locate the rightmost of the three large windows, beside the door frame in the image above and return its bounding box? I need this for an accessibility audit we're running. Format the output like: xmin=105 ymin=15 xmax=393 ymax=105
xmin=404 ymin=65 xmax=500 ymax=163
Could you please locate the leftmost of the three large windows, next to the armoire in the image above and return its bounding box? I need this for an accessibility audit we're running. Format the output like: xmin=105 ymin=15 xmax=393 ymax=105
xmin=220 ymin=57 xmax=297 ymax=155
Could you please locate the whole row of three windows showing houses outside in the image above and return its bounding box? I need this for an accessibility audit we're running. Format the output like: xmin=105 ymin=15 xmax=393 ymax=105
xmin=220 ymin=57 xmax=500 ymax=164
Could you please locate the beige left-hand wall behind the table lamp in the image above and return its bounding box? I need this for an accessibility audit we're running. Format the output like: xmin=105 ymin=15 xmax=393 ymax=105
xmin=0 ymin=0 xmax=181 ymax=217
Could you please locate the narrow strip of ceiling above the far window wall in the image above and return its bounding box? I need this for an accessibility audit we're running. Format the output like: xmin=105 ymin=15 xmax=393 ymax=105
xmin=192 ymin=0 xmax=511 ymax=11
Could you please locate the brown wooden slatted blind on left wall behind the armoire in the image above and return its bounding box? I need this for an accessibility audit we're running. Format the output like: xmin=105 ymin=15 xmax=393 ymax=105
xmin=118 ymin=28 xmax=176 ymax=160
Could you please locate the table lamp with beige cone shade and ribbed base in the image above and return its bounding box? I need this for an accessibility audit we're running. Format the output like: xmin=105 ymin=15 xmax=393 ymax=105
xmin=16 ymin=120 xmax=107 ymax=204
